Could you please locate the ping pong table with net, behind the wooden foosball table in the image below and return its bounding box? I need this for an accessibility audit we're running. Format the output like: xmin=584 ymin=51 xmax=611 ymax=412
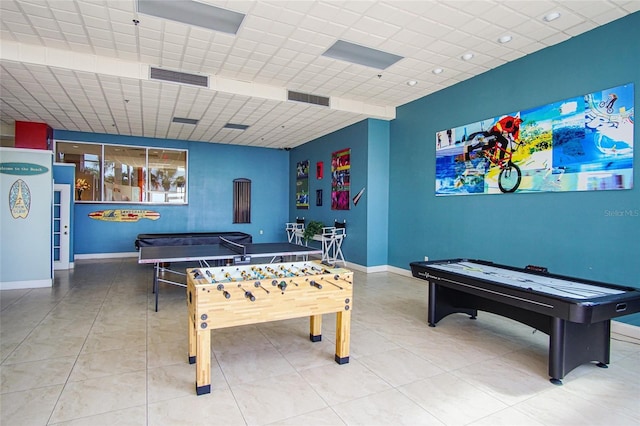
xmin=138 ymin=237 xmax=322 ymax=312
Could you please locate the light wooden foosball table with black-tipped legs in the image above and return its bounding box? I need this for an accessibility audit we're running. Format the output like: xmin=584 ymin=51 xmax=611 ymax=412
xmin=187 ymin=261 xmax=353 ymax=395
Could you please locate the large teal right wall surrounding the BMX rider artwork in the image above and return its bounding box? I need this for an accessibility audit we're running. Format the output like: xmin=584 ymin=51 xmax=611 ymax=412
xmin=388 ymin=13 xmax=640 ymax=325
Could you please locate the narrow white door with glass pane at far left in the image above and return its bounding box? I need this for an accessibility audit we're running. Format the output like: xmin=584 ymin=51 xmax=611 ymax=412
xmin=53 ymin=184 xmax=71 ymax=269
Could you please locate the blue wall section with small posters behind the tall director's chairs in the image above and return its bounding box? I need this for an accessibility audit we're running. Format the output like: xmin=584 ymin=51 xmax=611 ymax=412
xmin=290 ymin=120 xmax=389 ymax=266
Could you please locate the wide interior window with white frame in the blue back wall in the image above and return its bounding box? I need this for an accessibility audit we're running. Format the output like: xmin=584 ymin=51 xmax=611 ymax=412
xmin=56 ymin=142 xmax=187 ymax=204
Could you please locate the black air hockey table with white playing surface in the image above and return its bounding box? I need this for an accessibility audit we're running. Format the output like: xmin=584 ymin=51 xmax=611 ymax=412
xmin=410 ymin=259 xmax=640 ymax=385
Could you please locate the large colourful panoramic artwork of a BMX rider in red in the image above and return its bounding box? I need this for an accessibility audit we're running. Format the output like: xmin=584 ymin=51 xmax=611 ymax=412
xmin=435 ymin=84 xmax=634 ymax=195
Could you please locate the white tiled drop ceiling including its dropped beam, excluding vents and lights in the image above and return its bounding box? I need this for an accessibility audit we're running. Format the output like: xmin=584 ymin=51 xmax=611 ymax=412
xmin=0 ymin=0 xmax=640 ymax=149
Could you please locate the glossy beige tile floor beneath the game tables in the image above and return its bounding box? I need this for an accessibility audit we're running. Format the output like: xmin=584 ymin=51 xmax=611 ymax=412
xmin=0 ymin=258 xmax=640 ymax=426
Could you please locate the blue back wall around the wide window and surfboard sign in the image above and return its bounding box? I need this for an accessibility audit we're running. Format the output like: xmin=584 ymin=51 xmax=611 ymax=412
xmin=54 ymin=130 xmax=289 ymax=255
